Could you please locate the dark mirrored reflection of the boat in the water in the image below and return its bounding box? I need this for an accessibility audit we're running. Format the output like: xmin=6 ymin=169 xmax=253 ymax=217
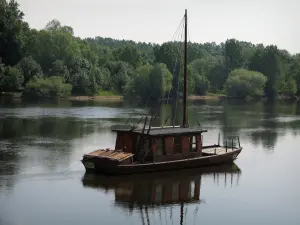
xmin=82 ymin=163 xmax=241 ymax=224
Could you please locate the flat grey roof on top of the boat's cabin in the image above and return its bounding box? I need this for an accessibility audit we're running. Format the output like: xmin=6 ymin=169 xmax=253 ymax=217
xmin=134 ymin=127 xmax=207 ymax=136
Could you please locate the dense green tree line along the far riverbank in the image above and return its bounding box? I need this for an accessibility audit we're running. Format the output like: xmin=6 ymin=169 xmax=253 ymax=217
xmin=0 ymin=0 xmax=300 ymax=99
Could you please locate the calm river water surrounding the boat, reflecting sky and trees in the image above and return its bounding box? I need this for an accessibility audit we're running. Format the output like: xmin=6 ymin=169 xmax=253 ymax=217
xmin=0 ymin=100 xmax=300 ymax=225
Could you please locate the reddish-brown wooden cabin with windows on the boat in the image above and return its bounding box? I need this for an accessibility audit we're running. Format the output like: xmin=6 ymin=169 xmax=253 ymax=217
xmin=112 ymin=127 xmax=206 ymax=162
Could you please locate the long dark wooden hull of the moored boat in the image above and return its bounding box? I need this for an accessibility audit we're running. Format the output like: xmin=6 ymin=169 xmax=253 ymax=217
xmin=82 ymin=148 xmax=242 ymax=175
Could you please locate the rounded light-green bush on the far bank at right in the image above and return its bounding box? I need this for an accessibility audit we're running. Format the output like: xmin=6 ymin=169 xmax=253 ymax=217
xmin=224 ymin=69 xmax=267 ymax=99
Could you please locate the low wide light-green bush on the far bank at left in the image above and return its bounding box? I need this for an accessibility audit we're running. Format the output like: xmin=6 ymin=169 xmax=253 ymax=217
xmin=26 ymin=76 xmax=72 ymax=98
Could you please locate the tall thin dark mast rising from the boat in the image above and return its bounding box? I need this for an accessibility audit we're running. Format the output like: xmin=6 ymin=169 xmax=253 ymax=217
xmin=182 ymin=10 xmax=188 ymax=127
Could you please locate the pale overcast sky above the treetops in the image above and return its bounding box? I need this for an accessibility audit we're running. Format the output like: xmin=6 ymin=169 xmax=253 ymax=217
xmin=17 ymin=0 xmax=300 ymax=53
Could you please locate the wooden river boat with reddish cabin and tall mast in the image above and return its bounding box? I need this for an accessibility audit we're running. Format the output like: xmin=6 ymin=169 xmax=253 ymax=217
xmin=81 ymin=11 xmax=242 ymax=174
